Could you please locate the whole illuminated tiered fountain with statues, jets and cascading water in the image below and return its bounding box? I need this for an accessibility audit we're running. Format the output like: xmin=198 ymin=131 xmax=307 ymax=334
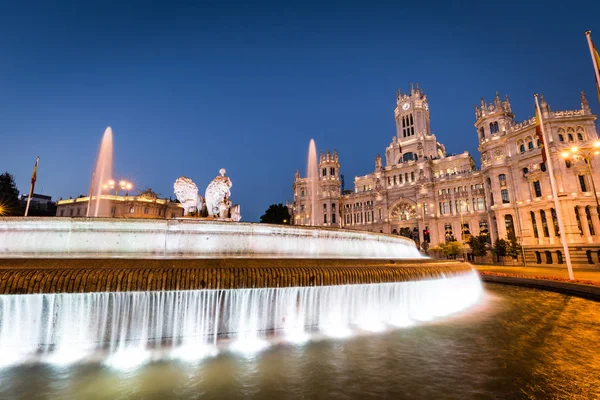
xmin=0 ymin=128 xmax=482 ymax=368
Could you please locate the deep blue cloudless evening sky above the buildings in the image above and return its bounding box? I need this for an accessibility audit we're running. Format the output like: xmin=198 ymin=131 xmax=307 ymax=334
xmin=0 ymin=0 xmax=600 ymax=221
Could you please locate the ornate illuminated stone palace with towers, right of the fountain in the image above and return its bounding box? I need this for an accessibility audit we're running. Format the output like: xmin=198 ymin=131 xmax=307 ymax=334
xmin=292 ymin=85 xmax=600 ymax=264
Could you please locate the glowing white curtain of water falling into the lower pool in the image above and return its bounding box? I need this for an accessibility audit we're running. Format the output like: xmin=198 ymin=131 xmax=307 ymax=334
xmin=0 ymin=271 xmax=482 ymax=367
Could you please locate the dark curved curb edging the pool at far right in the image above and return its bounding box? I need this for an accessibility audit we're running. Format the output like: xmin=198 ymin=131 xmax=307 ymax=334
xmin=479 ymin=273 xmax=600 ymax=301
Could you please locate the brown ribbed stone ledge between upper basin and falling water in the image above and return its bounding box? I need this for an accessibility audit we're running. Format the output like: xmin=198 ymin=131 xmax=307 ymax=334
xmin=0 ymin=259 xmax=472 ymax=295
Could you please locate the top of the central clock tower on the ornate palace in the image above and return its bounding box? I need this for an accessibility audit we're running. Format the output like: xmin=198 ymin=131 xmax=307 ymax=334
xmin=394 ymin=84 xmax=431 ymax=143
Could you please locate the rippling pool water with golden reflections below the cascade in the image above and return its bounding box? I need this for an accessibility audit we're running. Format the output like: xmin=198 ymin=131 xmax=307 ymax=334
xmin=0 ymin=285 xmax=600 ymax=399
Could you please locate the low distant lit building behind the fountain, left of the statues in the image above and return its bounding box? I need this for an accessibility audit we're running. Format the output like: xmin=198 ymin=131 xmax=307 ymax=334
xmin=56 ymin=189 xmax=183 ymax=218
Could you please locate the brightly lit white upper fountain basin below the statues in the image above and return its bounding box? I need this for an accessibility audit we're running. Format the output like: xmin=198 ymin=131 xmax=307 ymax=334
xmin=0 ymin=217 xmax=423 ymax=259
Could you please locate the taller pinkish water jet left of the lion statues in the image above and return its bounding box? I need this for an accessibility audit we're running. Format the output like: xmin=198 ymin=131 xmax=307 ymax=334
xmin=89 ymin=126 xmax=113 ymax=217
